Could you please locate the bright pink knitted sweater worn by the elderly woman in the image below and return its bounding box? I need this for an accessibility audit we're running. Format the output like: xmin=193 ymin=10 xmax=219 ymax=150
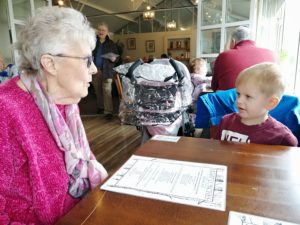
xmin=0 ymin=77 xmax=79 ymax=225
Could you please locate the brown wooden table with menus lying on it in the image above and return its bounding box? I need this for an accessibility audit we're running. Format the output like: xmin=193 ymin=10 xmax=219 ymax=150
xmin=58 ymin=137 xmax=300 ymax=225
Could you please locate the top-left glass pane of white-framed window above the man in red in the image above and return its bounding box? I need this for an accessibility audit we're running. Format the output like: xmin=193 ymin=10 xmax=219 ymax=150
xmin=201 ymin=0 xmax=222 ymax=26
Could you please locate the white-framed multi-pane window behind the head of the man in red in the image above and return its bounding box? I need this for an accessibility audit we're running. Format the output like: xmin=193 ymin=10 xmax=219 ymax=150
xmin=197 ymin=0 xmax=254 ymax=62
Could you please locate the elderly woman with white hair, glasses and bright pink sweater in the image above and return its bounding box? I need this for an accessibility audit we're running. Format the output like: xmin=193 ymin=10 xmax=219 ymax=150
xmin=0 ymin=7 xmax=107 ymax=224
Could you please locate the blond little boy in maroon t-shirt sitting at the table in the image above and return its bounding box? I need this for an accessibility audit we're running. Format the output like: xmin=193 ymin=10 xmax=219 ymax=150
xmin=214 ymin=63 xmax=298 ymax=146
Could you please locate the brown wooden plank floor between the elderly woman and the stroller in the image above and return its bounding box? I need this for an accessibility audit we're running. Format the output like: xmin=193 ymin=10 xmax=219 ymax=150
xmin=81 ymin=114 xmax=141 ymax=173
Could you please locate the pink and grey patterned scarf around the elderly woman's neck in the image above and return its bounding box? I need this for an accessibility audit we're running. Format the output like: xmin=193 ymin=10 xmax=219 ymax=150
xmin=21 ymin=74 xmax=107 ymax=198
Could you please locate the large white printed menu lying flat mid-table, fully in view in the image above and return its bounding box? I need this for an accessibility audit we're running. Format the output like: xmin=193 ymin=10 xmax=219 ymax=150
xmin=101 ymin=155 xmax=227 ymax=211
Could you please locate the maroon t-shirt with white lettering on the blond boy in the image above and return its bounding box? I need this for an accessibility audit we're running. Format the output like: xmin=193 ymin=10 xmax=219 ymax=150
xmin=214 ymin=113 xmax=298 ymax=146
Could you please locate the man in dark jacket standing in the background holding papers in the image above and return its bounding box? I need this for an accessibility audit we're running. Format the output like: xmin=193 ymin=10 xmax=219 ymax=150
xmin=92 ymin=23 xmax=118 ymax=119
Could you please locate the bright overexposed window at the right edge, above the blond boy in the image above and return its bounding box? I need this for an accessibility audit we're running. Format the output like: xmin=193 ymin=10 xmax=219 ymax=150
xmin=256 ymin=0 xmax=300 ymax=96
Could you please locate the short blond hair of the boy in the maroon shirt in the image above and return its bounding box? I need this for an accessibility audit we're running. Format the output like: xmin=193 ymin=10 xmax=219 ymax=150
xmin=235 ymin=63 xmax=285 ymax=99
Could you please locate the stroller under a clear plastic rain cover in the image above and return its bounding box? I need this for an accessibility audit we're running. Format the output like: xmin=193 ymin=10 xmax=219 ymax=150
xmin=114 ymin=59 xmax=193 ymax=142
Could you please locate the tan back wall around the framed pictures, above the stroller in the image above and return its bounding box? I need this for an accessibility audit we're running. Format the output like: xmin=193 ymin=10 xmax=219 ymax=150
xmin=113 ymin=29 xmax=196 ymax=60
